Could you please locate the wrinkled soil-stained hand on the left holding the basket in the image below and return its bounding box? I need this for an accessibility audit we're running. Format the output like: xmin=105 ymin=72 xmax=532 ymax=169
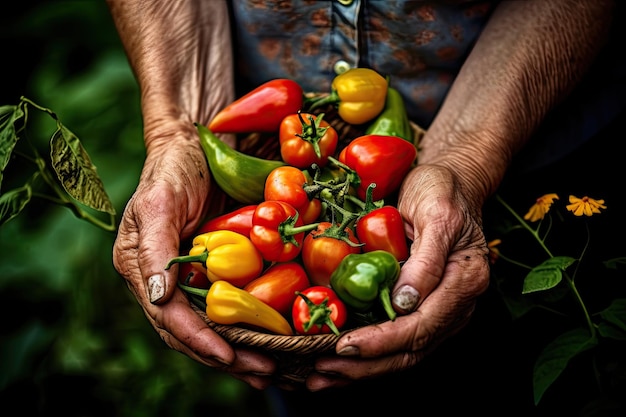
xmin=113 ymin=123 xmax=275 ymax=389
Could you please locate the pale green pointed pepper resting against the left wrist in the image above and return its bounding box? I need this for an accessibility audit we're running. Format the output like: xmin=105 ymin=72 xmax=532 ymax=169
xmin=196 ymin=123 xmax=285 ymax=204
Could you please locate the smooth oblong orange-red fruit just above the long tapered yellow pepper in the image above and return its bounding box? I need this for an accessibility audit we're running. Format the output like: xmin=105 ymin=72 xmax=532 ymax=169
xmin=243 ymin=262 xmax=311 ymax=316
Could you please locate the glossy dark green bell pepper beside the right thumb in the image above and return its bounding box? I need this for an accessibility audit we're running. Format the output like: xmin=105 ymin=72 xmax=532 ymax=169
xmin=330 ymin=250 xmax=400 ymax=321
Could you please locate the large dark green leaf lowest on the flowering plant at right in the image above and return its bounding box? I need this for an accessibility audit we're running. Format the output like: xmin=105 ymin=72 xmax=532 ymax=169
xmin=533 ymin=328 xmax=598 ymax=405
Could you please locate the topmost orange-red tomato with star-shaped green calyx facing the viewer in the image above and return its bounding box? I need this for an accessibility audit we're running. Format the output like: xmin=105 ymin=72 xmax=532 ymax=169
xmin=278 ymin=112 xmax=338 ymax=169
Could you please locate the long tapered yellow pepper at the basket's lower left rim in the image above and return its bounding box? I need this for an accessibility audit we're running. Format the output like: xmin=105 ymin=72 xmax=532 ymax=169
xmin=179 ymin=281 xmax=293 ymax=335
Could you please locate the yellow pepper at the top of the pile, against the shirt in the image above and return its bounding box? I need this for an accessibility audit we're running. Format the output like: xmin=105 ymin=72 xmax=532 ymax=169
xmin=307 ymin=68 xmax=388 ymax=125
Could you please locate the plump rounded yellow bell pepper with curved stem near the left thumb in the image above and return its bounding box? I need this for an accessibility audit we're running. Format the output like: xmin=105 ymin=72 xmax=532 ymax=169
xmin=165 ymin=230 xmax=264 ymax=288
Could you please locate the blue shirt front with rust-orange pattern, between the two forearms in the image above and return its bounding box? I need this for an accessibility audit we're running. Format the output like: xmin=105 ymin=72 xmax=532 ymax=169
xmin=229 ymin=0 xmax=497 ymax=126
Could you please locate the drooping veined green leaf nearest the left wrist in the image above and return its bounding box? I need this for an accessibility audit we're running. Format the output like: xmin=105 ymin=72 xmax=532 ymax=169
xmin=50 ymin=122 xmax=115 ymax=215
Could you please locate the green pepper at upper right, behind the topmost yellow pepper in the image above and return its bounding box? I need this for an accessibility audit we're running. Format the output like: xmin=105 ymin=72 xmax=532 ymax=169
xmin=365 ymin=87 xmax=414 ymax=142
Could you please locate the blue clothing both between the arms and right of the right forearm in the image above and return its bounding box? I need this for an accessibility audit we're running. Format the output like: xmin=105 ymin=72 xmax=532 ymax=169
xmin=230 ymin=0 xmax=626 ymax=170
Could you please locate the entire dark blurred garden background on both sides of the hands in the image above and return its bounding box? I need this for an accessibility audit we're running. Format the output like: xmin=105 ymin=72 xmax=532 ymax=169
xmin=0 ymin=0 xmax=626 ymax=417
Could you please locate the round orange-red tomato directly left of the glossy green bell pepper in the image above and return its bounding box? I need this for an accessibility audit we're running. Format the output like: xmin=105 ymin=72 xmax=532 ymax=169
xmin=302 ymin=222 xmax=361 ymax=287
